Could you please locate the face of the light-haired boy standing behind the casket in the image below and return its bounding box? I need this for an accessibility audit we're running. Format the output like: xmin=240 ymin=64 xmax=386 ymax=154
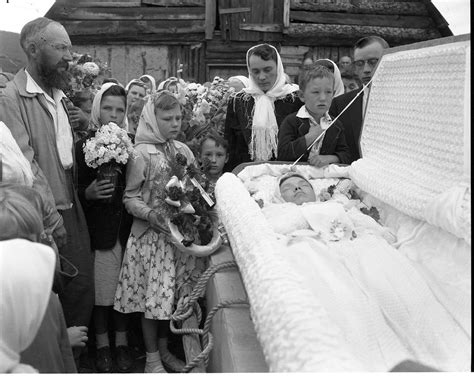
xmin=301 ymin=77 xmax=334 ymax=121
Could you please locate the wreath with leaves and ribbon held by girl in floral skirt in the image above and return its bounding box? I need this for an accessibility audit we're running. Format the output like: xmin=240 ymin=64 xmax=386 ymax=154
xmin=152 ymin=153 xmax=222 ymax=256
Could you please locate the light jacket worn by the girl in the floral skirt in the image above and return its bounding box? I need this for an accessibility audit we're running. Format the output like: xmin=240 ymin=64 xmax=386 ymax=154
xmin=123 ymin=141 xmax=194 ymax=238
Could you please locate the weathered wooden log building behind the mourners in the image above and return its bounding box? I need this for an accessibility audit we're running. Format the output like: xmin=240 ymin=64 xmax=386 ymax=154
xmin=46 ymin=0 xmax=452 ymax=83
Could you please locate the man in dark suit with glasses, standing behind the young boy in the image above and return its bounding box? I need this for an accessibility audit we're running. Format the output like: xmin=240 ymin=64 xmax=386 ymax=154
xmin=329 ymin=36 xmax=389 ymax=161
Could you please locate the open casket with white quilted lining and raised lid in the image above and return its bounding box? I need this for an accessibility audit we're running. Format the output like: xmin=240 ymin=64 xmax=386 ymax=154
xmin=211 ymin=36 xmax=471 ymax=372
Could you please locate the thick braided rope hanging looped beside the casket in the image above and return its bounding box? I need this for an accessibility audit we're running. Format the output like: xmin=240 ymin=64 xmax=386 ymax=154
xmin=170 ymin=261 xmax=249 ymax=373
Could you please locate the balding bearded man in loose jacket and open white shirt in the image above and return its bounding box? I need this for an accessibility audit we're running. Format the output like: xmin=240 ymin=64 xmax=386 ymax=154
xmin=0 ymin=17 xmax=94 ymax=334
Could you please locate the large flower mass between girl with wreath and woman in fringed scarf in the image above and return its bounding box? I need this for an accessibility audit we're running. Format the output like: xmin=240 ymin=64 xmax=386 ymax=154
xmin=178 ymin=76 xmax=234 ymax=151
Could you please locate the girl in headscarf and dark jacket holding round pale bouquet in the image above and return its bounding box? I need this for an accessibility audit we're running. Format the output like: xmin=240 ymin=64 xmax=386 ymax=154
xmin=76 ymin=83 xmax=133 ymax=372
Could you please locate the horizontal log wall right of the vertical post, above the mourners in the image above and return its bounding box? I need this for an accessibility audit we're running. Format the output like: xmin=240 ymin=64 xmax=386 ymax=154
xmin=284 ymin=0 xmax=452 ymax=46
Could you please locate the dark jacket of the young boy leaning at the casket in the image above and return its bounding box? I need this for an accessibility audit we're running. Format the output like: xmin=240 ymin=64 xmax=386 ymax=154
xmin=277 ymin=112 xmax=352 ymax=164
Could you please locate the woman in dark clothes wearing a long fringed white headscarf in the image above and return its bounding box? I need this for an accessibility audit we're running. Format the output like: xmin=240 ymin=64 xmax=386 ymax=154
xmin=225 ymin=44 xmax=303 ymax=171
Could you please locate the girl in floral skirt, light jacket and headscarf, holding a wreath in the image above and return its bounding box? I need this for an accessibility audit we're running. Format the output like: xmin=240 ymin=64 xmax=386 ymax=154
xmin=114 ymin=90 xmax=205 ymax=372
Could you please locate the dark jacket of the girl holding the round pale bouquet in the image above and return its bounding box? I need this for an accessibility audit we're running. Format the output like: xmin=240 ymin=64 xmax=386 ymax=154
xmin=76 ymin=132 xmax=133 ymax=250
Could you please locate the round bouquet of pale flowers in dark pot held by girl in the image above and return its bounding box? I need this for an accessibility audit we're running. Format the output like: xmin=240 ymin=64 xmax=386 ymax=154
xmin=83 ymin=123 xmax=136 ymax=202
